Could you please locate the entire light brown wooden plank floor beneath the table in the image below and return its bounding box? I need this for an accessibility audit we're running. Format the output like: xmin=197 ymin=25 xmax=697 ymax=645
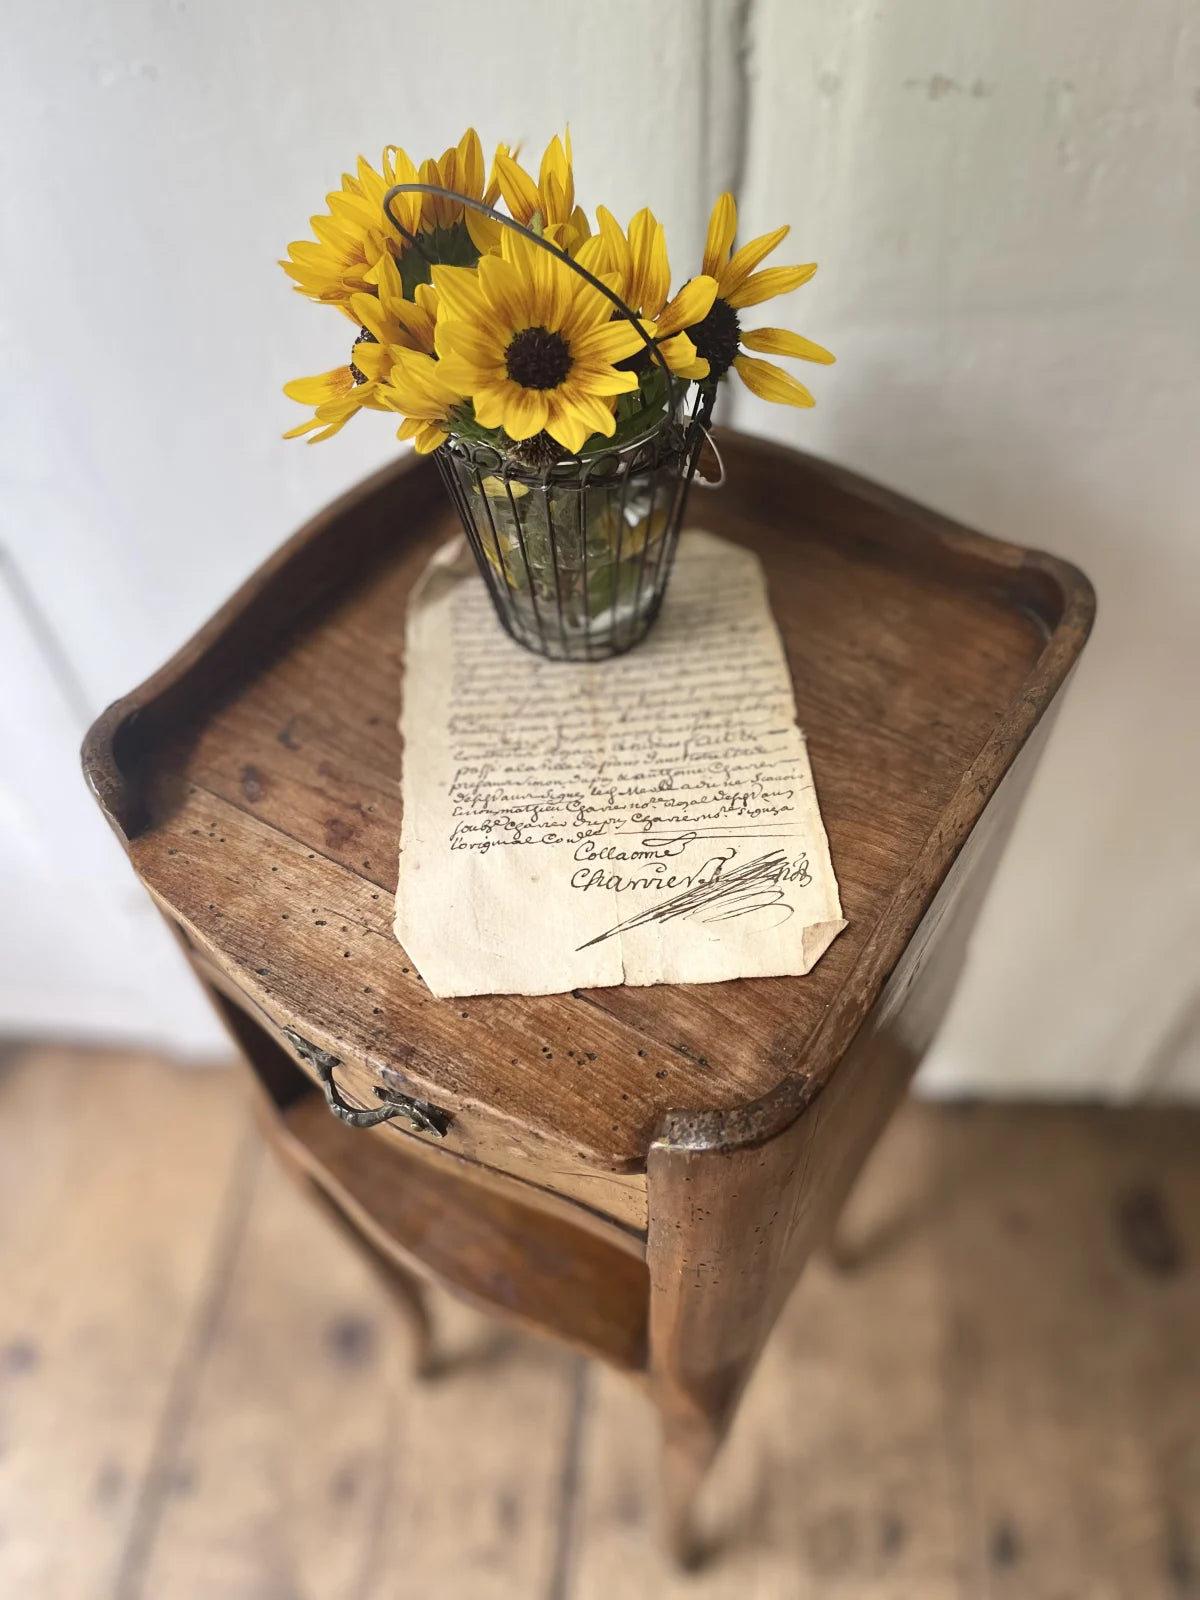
xmin=0 ymin=1046 xmax=1200 ymax=1600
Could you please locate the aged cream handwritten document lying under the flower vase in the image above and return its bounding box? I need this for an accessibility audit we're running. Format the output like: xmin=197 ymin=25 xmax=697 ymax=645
xmin=395 ymin=531 xmax=845 ymax=995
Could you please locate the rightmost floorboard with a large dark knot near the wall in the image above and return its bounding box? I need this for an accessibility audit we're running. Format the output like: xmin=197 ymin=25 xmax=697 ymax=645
xmin=938 ymin=1109 xmax=1200 ymax=1600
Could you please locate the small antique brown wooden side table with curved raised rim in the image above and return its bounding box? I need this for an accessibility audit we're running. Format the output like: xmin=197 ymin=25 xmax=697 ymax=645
xmin=83 ymin=435 xmax=1093 ymax=1558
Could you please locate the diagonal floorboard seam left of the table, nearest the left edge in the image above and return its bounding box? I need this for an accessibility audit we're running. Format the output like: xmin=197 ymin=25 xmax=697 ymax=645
xmin=112 ymin=1128 xmax=262 ymax=1600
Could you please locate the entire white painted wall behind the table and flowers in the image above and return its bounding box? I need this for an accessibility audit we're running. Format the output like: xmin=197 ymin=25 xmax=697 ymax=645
xmin=0 ymin=0 xmax=1200 ymax=1096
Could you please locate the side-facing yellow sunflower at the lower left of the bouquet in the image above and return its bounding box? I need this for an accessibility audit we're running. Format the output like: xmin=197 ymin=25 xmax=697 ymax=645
xmin=283 ymin=254 xmax=462 ymax=445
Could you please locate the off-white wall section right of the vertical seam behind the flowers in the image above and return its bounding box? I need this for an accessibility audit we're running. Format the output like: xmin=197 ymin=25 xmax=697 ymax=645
xmin=736 ymin=0 xmax=1200 ymax=1096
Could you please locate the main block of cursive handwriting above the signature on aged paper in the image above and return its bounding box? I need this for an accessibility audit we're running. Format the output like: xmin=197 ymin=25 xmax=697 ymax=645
xmin=448 ymin=557 xmax=811 ymax=870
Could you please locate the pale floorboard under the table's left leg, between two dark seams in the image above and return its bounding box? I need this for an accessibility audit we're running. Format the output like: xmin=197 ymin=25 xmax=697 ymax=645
xmin=141 ymin=1145 xmax=573 ymax=1600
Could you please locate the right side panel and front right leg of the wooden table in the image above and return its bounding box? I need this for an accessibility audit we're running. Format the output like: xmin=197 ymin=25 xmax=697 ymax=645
xmin=646 ymin=729 xmax=1037 ymax=1563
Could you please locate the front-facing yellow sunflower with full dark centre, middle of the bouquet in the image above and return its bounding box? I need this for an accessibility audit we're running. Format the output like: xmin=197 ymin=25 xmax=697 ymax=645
xmin=434 ymin=229 xmax=642 ymax=453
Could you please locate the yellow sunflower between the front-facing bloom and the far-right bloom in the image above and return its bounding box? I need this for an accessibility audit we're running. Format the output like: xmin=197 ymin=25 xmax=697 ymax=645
xmin=574 ymin=206 xmax=717 ymax=379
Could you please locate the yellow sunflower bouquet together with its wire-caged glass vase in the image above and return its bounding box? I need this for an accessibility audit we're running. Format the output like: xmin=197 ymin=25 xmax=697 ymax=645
xmin=282 ymin=128 xmax=834 ymax=659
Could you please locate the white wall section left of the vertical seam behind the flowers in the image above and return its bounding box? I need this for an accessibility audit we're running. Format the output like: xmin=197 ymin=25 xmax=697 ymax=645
xmin=0 ymin=0 xmax=739 ymax=1051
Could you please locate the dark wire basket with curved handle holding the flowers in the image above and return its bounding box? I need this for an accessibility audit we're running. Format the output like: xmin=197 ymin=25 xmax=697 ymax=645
xmin=384 ymin=184 xmax=714 ymax=661
